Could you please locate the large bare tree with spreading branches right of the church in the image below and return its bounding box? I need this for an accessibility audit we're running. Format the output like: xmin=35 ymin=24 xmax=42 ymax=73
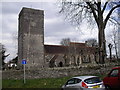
xmin=60 ymin=0 xmax=120 ymax=63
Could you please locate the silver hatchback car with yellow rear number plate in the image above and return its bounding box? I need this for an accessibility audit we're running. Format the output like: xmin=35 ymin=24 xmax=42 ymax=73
xmin=62 ymin=76 xmax=104 ymax=90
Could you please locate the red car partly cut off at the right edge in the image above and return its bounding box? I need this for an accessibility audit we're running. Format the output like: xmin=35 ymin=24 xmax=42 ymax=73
xmin=103 ymin=67 xmax=120 ymax=90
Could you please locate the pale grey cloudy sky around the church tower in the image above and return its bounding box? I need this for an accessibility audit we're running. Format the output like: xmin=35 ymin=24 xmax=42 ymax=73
xmin=0 ymin=2 xmax=118 ymax=61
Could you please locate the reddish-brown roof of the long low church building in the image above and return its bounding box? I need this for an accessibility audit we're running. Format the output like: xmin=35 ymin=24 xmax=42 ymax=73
xmin=44 ymin=42 xmax=95 ymax=54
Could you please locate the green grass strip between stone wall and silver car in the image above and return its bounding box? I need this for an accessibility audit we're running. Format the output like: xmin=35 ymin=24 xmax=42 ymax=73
xmin=2 ymin=75 xmax=105 ymax=88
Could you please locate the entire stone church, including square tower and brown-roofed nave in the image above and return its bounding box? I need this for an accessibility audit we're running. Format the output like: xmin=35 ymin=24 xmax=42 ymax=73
xmin=18 ymin=7 xmax=98 ymax=69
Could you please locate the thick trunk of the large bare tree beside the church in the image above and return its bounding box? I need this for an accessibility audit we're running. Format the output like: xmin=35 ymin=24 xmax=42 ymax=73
xmin=97 ymin=2 xmax=106 ymax=64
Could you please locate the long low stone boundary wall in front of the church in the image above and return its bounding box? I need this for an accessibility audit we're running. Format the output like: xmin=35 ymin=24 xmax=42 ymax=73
xmin=2 ymin=64 xmax=120 ymax=79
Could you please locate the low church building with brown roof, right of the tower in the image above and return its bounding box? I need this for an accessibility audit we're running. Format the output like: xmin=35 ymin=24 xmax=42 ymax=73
xmin=44 ymin=42 xmax=99 ymax=67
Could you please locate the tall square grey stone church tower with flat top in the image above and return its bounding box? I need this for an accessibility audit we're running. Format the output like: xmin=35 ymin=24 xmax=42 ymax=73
xmin=18 ymin=8 xmax=45 ymax=69
